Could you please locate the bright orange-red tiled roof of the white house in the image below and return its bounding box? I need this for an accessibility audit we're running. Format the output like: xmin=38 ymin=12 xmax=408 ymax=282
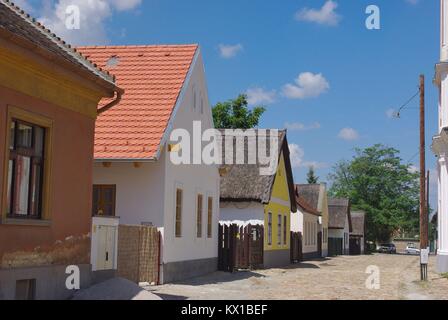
xmin=78 ymin=45 xmax=198 ymax=160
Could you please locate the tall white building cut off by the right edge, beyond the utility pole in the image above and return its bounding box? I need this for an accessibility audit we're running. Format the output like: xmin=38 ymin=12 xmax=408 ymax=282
xmin=432 ymin=0 xmax=448 ymax=273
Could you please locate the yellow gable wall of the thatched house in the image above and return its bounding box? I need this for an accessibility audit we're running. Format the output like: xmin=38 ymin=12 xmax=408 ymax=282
xmin=264 ymin=153 xmax=291 ymax=251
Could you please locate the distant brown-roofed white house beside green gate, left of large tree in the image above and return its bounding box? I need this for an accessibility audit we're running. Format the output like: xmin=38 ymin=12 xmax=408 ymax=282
xmin=328 ymin=198 xmax=352 ymax=256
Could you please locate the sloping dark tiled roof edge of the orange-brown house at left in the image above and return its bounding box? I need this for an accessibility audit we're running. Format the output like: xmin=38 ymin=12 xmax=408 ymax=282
xmin=0 ymin=0 xmax=115 ymax=85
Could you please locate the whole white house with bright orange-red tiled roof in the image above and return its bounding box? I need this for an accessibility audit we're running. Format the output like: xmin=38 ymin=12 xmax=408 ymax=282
xmin=79 ymin=45 xmax=219 ymax=283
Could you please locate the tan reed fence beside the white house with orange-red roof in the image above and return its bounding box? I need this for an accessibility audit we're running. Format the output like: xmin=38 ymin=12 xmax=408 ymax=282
xmin=118 ymin=225 xmax=160 ymax=284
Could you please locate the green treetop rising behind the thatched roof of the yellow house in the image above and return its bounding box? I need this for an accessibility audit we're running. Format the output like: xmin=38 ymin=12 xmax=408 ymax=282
xmin=212 ymin=94 xmax=266 ymax=129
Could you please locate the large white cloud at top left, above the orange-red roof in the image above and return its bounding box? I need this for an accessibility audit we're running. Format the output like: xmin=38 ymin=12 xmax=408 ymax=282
xmin=39 ymin=0 xmax=142 ymax=45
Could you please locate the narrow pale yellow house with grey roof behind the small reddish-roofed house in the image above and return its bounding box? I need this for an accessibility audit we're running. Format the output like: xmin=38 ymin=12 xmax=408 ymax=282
xmin=296 ymin=183 xmax=328 ymax=257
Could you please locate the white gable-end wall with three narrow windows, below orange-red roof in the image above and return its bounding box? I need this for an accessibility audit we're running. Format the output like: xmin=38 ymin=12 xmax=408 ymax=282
xmin=163 ymin=55 xmax=220 ymax=263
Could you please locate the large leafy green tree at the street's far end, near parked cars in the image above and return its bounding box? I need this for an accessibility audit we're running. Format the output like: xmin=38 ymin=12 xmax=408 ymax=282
xmin=329 ymin=144 xmax=419 ymax=241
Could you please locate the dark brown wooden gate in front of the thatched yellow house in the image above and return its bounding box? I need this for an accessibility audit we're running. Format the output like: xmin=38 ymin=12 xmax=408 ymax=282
xmin=218 ymin=224 xmax=264 ymax=272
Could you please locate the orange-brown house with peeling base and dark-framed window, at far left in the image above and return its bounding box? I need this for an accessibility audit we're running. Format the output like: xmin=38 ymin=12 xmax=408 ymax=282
xmin=0 ymin=0 xmax=120 ymax=299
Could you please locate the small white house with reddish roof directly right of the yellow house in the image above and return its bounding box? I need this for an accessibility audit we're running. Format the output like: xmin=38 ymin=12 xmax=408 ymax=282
xmin=291 ymin=188 xmax=322 ymax=260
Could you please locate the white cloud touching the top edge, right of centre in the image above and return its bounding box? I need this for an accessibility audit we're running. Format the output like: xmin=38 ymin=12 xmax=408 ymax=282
xmin=295 ymin=0 xmax=342 ymax=26
